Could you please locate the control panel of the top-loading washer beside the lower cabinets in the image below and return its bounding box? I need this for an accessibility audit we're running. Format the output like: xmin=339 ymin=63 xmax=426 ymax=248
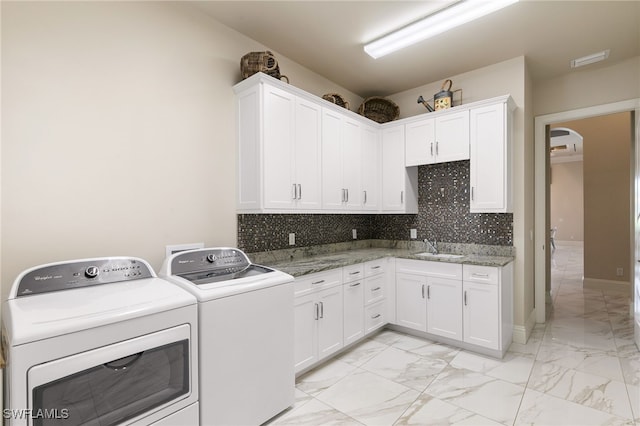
xmin=170 ymin=248 xmax=251 ymax=275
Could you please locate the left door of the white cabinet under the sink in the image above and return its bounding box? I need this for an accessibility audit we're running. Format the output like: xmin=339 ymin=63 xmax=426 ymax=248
xmin=396 ymin=273 xmax=427 ymax=331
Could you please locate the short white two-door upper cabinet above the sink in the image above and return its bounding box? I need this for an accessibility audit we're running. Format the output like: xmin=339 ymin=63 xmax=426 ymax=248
xmin=405 ymin=110 xmax=469 ymax=167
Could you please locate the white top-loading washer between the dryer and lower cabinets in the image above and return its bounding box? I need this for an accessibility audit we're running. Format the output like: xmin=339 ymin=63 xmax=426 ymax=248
xmin=159 ymin=248 xmax=295 ymax=426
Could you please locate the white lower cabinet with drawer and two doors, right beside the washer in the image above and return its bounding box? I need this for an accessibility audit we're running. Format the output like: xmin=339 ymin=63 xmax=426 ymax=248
xmin=294 ymin=269 xmax=344 ymax=372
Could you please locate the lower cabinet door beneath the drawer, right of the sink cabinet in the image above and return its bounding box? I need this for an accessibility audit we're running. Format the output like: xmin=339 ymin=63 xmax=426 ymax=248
xmin=463 ymin=281 xmax=500 ymax=349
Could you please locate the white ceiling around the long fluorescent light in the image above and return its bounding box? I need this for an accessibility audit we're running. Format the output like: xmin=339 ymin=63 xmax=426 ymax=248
xmin=191 ymin=0 xmax=640 ymax=97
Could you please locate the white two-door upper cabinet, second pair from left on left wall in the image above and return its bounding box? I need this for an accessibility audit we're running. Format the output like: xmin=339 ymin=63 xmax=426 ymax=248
xmin=322 ymin=108 xmax=362 ymax=210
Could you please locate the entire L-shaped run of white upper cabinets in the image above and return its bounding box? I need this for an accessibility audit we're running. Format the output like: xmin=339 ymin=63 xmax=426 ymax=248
xmin=234 ymin=73 xmax=514 ymax=214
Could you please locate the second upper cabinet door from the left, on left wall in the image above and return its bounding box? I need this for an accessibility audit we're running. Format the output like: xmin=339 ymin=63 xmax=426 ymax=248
xmin=296 ymin=98 xmax=322 ymax=210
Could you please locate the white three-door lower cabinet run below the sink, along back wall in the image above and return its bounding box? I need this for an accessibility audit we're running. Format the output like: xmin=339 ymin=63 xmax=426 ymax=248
xmin=395 ymin=259 xmax=513 ymax=356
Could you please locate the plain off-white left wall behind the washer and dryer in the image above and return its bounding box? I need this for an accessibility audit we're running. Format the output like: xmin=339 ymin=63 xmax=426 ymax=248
xmin=0 ymin=1 xmax=361 ymax=298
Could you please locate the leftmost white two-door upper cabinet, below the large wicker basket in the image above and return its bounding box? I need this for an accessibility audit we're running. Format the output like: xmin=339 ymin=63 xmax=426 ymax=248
xmin=237 ymin=77 xmax=322 ymax=212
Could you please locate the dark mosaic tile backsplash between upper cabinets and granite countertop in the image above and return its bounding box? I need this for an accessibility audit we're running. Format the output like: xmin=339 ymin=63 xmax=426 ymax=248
xmin=238 ymin=160 xmax=513 ymax=253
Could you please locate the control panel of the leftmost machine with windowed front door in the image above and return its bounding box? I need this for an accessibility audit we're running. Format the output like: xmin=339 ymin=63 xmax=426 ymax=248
xmin=14 ymin=257 xmax=155 ymax=297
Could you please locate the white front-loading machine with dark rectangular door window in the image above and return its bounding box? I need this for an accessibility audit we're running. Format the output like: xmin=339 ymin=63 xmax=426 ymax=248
xmin=2 ymin=257 xmax=199 ymax=426
